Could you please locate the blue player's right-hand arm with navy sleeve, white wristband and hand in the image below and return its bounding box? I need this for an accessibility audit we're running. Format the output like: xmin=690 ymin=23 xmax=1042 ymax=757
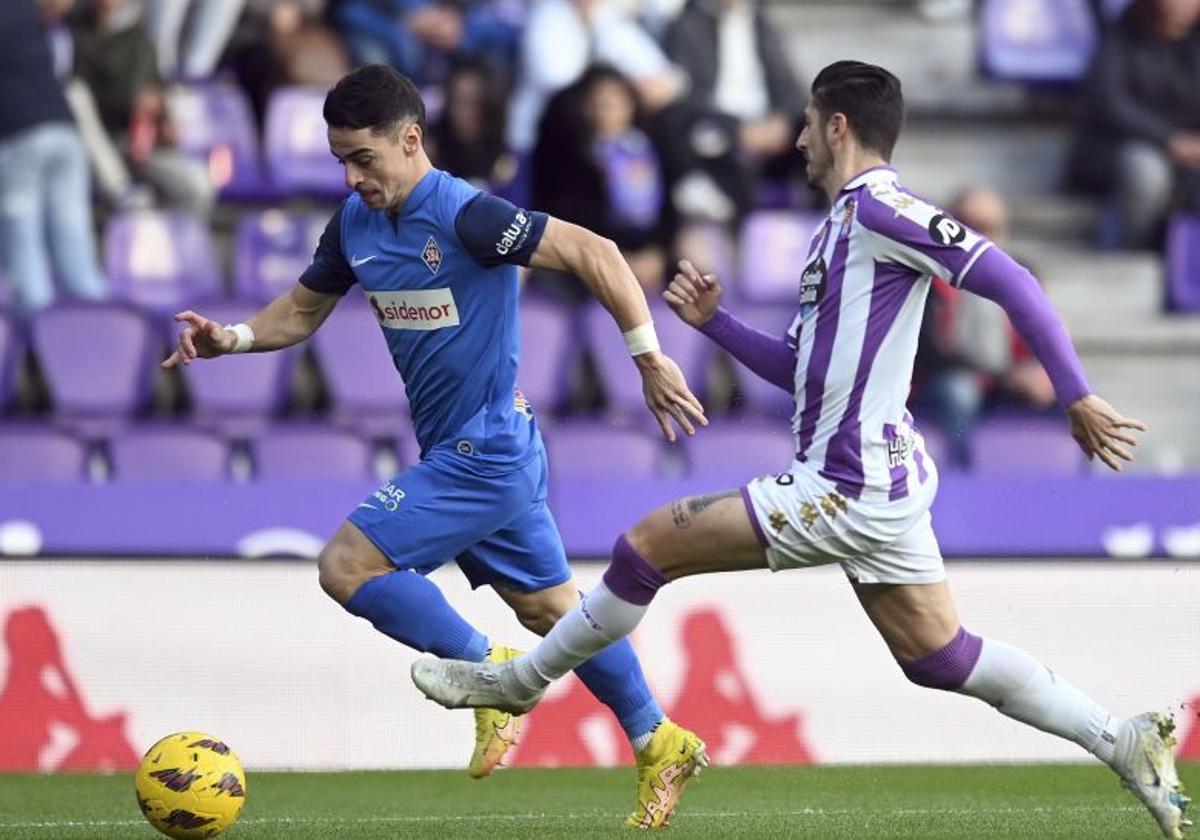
xmin=456 ymin=193 xmax=708 ymax=440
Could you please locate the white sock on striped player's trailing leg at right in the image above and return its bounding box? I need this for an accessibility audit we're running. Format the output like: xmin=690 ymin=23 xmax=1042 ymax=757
xmin=959 ymin=638 xmax=1121 ymax=766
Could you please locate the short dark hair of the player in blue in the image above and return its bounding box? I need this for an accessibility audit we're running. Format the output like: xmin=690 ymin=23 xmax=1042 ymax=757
xmin=323 ymin=64 xmax=425 ymax=134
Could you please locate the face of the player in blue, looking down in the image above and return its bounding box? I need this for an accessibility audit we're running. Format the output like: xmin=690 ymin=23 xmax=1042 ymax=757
xmin=329 ymin=124 xmax=421 ymax=210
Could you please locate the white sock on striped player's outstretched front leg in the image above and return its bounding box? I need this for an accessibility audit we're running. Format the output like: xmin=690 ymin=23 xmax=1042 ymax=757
xmin=514 ymin=582 xmax=647 ymax=689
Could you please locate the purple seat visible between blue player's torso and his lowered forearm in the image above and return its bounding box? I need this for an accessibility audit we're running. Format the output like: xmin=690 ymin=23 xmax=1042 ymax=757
xmin=517 ymin=295 xmax=580 ymax=414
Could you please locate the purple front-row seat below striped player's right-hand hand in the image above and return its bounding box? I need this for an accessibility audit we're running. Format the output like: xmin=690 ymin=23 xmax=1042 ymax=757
xmin=971 ymin=418 xmax=1087 ymax=475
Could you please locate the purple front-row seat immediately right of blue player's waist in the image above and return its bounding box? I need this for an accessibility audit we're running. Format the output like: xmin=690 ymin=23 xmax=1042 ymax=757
xmin=542 ymin=422 xmax=661 ymax=479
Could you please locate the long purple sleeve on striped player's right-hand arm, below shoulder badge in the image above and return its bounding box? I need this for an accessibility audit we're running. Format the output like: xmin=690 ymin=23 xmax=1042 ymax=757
xmin=962 ymin=247 xmax=1092 ymax=408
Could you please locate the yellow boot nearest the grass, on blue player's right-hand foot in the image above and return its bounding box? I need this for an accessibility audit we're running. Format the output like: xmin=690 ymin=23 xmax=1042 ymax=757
xmin=625 ymin=719 xmax=708 ymax=828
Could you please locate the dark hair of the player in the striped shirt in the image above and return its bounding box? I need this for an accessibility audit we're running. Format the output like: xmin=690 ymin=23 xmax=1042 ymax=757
xmin=812 ymin=61 xmax=904 ymax=161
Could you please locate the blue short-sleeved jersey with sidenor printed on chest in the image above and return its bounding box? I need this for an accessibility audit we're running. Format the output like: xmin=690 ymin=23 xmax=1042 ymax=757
xmin=300 ymin=169 xmax=546 ymax=472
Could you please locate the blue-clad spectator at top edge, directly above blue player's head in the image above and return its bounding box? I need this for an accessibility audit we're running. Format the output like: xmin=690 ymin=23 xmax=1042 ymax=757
xmin=334 ymin=0 xmax=524 ymax=85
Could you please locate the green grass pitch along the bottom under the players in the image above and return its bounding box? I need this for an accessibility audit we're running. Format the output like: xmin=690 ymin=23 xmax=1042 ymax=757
xmin=0 ymin=764 xmax=1200 ymax=840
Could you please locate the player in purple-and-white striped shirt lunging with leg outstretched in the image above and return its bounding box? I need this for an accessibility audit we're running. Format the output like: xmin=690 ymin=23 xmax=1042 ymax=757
xmin=413 ymin=61 xmax=1190 ymax=838
